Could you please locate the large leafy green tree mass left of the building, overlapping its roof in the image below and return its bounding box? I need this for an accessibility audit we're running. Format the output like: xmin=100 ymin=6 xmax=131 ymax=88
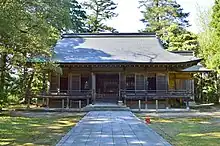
xmin=0 ymin=0 xmax=85 ymax=105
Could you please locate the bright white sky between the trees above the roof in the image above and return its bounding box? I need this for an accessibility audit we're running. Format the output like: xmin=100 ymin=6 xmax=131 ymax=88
xmin=80 ymin=0 xmax=214 ymax=32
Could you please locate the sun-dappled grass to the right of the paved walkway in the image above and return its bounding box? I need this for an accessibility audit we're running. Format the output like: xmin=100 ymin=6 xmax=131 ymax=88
xmin=137 ymin=115 xmax=220 ymax=146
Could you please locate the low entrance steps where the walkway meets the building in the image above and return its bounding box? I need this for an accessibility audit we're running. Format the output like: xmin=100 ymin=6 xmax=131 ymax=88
xmin=83 ymin=103 xmax=131 ymax=112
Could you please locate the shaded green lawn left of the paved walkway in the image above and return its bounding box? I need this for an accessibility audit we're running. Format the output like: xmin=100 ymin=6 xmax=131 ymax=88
xmin=0 ymin=113 xmax=82 ymax=146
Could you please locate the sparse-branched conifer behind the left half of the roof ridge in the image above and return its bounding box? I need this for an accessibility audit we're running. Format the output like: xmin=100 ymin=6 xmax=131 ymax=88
xmin=83 ymin=0 xmax=117 ymax=32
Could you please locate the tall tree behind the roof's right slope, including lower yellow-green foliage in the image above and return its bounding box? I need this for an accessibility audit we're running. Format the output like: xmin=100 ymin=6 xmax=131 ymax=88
xmin=139 ymin=0 xmax=198 ymax=50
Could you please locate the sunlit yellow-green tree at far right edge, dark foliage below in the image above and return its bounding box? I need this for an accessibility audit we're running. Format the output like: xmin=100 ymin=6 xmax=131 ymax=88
xmin=197 ymin=5 xmax=220 ymax=103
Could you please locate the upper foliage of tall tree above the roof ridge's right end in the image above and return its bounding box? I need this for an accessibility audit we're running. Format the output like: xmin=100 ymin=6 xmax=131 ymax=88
xmin=139 ymin=0 xmax=189 ymax=32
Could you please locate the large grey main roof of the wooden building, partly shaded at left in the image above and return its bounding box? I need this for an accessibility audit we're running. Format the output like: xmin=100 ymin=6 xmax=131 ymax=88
xmin=53 ymin=33 xmax=200 ymax=63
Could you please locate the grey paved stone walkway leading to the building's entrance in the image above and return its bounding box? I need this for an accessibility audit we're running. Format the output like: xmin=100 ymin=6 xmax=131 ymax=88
xmin=57 ymin=111 xmax=170 ymax=146
